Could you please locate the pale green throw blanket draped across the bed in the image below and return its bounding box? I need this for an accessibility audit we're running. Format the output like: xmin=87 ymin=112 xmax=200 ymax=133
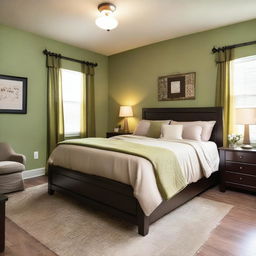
xmin=59 ymin=138 xmax=187 ymax=200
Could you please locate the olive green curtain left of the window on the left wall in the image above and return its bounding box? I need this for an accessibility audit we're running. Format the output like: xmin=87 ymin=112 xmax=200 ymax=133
xmin=46 ymin=55 xmax=64 ymax=155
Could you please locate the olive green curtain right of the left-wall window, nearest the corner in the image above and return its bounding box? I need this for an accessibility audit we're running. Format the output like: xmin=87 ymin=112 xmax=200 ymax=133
xmin=80 ymin=64 xmax=96 ymax=138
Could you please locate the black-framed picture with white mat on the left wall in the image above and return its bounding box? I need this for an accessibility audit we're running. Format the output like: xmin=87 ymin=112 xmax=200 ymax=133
xmin=0 ymin=75 xmax=27 ymax=114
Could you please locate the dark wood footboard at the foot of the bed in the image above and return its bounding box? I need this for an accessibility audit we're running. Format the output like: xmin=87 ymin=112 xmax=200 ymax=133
xmin=48 ymin=165 xmax=149 ymax=236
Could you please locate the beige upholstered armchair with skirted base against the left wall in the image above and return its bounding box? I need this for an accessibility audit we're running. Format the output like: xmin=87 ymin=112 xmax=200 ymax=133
xmin=0 ymin=143 xmax=26 ymax=194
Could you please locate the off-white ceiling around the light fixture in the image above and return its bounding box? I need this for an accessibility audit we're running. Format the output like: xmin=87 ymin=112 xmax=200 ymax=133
xmin=0 ymin=0 xmax=256 ymax=55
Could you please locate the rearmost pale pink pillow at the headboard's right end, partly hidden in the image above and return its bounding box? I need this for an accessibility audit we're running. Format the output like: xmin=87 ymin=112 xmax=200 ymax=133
xmin=171 ymin=121 xmax=216 ymax=141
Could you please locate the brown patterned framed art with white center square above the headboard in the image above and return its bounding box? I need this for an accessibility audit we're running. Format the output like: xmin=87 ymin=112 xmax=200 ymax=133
xmin=158 ymin=72 xmax=196 ymax=101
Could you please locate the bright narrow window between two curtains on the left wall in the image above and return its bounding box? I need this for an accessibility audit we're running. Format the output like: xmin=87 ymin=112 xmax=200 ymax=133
xmin=61 ymin=69 xmax=83 ymax=137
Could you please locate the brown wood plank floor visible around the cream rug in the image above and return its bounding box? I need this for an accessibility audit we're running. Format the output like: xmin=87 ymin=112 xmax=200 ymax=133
xmin=0 ymin=177 xmax=256 ymax=256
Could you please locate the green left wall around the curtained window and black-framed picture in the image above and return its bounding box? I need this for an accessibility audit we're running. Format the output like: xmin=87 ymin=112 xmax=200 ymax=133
xmin=0 ymin=25 xmax=108 ymax=169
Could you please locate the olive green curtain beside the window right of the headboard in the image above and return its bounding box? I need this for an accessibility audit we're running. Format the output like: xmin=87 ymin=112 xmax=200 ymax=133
xmin=215 ymin=49 xmax=234 ymax=146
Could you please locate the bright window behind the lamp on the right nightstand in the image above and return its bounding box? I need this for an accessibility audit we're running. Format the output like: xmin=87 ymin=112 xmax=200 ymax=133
xmin=232 ymin=56 xmax=256 ymax=143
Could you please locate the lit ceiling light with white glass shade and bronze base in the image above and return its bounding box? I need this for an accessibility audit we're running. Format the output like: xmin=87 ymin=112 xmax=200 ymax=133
xmin=95 ymin=3 xmax=118 ymax=31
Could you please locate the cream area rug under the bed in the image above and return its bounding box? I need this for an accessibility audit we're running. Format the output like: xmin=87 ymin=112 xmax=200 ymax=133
xmin=7 ymin=184 xmax=232 ymax=256
